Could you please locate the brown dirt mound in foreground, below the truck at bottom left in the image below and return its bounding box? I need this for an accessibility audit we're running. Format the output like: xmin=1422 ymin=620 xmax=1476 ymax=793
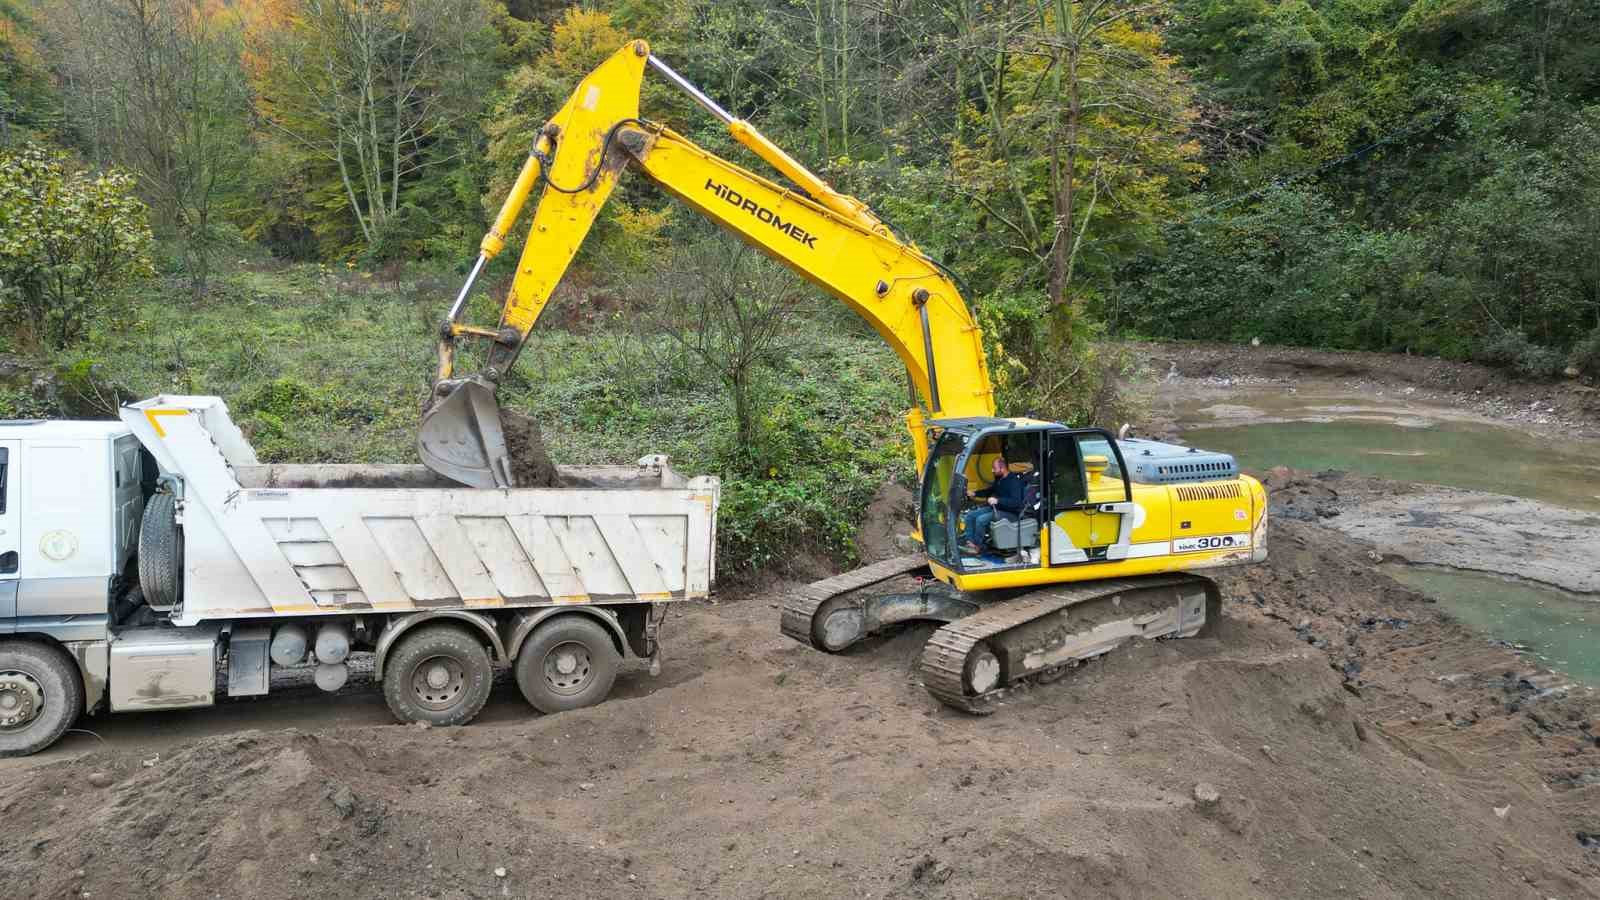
xmin=0 ymin=727 xmax=626 ymax=898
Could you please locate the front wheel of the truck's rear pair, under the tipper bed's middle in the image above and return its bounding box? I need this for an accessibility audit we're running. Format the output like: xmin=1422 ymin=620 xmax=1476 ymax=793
xmin=384 ymin=625 xmax=494 ymax=725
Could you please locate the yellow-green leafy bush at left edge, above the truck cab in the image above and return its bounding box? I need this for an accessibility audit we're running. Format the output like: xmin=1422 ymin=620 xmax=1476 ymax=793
xmin=0 ymin=144 xmax=154 ymax=349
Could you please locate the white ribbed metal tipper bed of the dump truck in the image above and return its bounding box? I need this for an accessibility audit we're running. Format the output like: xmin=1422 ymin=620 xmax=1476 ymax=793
xmin=122 ymin=397 xmax=718 ymax=625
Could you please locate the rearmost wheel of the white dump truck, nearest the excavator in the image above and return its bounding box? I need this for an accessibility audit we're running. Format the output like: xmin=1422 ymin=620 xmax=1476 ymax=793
xmin=515 ymin=615 xmax=622 ymax=713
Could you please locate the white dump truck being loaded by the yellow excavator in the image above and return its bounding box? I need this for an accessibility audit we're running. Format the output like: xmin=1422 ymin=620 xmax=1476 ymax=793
xmin=0 ymin=396 xmax=720 ymax=756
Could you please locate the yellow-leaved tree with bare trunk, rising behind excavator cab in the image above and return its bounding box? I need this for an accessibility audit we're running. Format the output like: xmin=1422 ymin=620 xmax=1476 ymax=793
xmin=957 ymin=0 xmax=1198 ymax=318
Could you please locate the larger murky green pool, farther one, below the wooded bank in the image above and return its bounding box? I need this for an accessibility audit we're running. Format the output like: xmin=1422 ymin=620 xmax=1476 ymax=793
xmin=1184 ymin=420 xmax=1600 ymax=511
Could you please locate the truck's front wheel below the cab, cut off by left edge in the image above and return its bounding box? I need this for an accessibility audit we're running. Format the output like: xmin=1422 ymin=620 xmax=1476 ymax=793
xmin=0 ymin=641 xmax=83 ymax=756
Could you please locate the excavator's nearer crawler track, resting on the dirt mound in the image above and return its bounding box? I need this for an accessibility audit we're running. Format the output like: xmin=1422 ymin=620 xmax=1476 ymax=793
xmin=922 ymin=575 xmax=1221 ymax=716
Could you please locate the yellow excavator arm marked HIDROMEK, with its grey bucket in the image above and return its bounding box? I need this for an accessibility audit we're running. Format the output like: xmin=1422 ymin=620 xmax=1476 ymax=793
xmin=418 ymin=40 xmax=994 ymax=487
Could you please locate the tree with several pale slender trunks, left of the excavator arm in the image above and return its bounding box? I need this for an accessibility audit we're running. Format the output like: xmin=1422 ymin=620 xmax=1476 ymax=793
xmin=248 ymin=0 xmax=494 ymax=251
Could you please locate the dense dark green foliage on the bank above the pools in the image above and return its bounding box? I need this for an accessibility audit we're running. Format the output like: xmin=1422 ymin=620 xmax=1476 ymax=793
xmin=1152 ymin=0 xmax=1600 ymax=376
